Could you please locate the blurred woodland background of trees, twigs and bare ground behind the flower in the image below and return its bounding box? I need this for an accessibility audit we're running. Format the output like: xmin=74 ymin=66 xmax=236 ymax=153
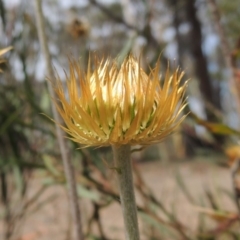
xmin=0 ymin=0 xmax=240 ymax=240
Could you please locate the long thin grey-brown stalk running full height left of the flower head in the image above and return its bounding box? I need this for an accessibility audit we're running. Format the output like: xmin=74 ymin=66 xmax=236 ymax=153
xmin=35 ymin=0 xmax=84 ymax=240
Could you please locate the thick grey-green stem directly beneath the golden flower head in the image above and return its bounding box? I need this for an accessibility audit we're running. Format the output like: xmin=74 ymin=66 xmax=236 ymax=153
xmin=112 ymin=145 xmax=139 ymax=240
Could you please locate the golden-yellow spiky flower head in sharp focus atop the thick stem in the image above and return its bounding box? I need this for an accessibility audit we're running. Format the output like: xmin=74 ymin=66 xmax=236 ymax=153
xmin=55 ymin=56 xmax=186 ymax=146
